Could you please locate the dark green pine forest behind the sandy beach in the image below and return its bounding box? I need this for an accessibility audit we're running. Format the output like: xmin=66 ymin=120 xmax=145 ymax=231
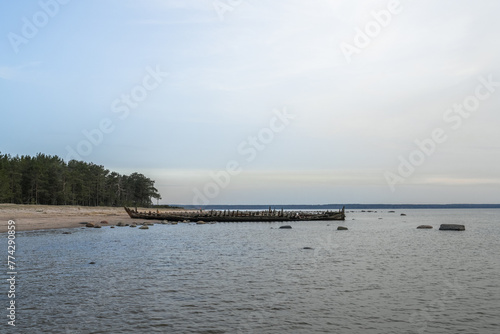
xmin=0 ymin=153 xmax=161 ymax=207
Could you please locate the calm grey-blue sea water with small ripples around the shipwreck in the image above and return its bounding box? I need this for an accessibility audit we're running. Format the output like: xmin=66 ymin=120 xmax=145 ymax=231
xmin=0 ymin=210 xmax=500 ymax=334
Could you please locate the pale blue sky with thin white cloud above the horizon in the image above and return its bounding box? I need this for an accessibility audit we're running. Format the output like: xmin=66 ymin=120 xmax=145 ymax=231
xmin=0 ymin=0 xmax=500 ymax=205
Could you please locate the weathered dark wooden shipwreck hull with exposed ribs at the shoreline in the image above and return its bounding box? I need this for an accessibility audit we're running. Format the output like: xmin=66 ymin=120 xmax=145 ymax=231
xmin=125 ymin=207 xmax=345 ymax=222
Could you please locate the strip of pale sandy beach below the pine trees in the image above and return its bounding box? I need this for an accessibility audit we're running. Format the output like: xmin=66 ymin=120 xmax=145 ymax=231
xmin=0 ymin=204 xmax=185 ymax=233
